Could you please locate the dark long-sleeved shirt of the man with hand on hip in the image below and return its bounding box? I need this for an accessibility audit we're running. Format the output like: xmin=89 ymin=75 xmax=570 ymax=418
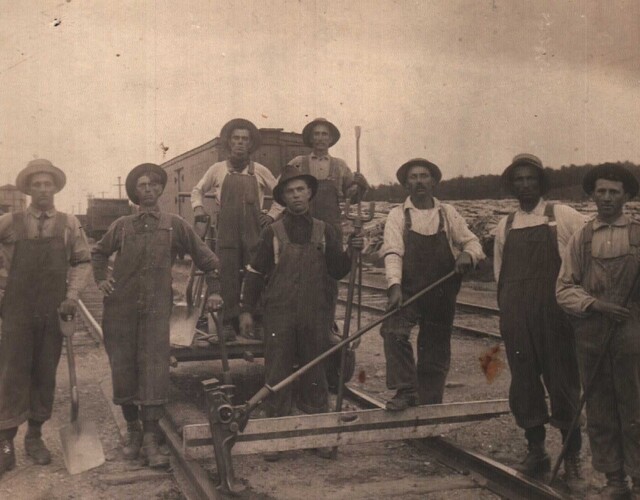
xmin=91 ymin=210 xmax=219 ymax=283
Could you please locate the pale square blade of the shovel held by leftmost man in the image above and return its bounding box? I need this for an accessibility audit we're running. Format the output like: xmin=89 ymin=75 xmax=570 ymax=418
xmin=60 ymin=418 xmax=104 ymax=474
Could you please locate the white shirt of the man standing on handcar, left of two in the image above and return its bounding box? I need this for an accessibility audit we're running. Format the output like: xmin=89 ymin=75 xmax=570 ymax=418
xmin=191 ymin=161 xmax=283 ymax=219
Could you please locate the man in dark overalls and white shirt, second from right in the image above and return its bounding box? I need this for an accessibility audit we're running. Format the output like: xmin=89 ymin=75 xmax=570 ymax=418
xmin=493 ymin=154 xmax=585 ymax=486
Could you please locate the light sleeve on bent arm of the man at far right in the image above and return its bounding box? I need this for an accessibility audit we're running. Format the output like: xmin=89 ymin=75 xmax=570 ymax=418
xmin=556 ymin=231 xmax=596 ymax=317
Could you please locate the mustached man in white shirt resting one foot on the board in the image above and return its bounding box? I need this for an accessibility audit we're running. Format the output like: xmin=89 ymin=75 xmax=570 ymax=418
xmin=380 ymin=158 xmax=485 ymax=411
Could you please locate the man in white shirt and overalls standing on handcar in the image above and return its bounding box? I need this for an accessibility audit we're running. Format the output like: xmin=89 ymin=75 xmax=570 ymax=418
xmin=191 ymin=118 xmax=281 ymax=340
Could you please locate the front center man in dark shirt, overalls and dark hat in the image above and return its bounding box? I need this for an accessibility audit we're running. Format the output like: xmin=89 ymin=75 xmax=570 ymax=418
xmin=240 ymin=166 xmax=363 ymax=460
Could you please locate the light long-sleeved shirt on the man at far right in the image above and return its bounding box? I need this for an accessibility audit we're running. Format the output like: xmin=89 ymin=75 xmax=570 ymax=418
xmin=556 ymin=214 xmax=631 ymax=317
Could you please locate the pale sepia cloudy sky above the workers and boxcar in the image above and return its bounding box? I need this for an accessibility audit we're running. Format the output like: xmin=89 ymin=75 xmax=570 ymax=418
xmin=0 ymin=0 xmax=640 ymax=213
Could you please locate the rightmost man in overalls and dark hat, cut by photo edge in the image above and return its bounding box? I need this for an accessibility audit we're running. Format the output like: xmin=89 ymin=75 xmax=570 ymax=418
xmin=556 ymin=163 xmax=640 ymax=499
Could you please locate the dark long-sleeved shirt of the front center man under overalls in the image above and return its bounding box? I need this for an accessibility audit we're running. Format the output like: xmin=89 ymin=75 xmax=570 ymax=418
xmin=242 ymin=210 xmax=351 ymax=312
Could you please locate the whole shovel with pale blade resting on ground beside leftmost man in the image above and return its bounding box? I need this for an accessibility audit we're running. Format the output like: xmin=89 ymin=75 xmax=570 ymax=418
xmin=60 ymin=317 xmax=104 ymax=474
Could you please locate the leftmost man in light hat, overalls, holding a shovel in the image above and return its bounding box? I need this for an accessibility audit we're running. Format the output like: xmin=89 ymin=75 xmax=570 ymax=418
xmin=0 ymin=159 xmax=91 ymax=474
